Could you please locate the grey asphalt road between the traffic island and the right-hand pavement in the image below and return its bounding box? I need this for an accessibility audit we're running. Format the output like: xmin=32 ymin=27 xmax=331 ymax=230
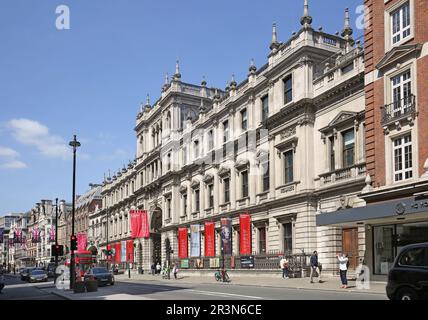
xmin=44 ymin=280 xmax=387 ymax=301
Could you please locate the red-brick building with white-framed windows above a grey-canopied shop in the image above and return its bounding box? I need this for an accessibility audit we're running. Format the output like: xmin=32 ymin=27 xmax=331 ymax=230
xmin=317 ymin=0 xmax=428 ymax=280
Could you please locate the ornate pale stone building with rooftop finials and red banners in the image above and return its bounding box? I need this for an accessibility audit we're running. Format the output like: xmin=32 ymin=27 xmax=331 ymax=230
xmin=96 ymin=1 xmax=366 ymax=274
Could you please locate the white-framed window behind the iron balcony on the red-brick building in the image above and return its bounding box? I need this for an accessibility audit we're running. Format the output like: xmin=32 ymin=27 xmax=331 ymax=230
xmin=391 ymin=69 xmax=412 ymax=117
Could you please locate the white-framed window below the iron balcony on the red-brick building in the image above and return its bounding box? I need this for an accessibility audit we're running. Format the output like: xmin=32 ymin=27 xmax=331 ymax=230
xmin=393 ymin=134 xmax=413 ymax=182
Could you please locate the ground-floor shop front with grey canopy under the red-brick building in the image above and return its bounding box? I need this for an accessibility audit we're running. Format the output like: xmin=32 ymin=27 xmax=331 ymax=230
xmin=317 ymin=196 xmax=428 ymax=281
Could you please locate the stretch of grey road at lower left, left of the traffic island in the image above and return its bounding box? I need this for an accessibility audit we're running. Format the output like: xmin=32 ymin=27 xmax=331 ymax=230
xmin=0 ymin=276 xmax=64 ymax=300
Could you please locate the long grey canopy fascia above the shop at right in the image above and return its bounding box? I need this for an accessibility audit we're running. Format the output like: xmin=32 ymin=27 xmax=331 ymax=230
xmin=316 ymin=197 xmax=428 ymax=226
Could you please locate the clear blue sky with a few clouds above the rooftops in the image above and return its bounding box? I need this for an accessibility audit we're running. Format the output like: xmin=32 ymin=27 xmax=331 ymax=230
xmin=0 ymin=0 xmax=363 ymax=215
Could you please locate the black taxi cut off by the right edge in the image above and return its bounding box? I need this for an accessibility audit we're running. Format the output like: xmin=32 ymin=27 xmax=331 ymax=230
xmin=386 ymin=243 xmax=428 ymax=300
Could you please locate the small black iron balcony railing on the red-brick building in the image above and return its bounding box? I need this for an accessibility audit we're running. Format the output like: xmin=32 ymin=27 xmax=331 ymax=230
xmin=381 ymin=94 xmax=416 ymax=125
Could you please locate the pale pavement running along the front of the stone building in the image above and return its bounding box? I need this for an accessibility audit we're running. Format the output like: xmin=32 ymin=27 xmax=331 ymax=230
xmin=115 ymin=273 xmax=386 ymax=294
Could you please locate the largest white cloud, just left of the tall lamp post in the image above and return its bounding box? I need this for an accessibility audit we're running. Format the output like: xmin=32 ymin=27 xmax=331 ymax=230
xmin=7 ymin=119 xmax=71 ymax=159
